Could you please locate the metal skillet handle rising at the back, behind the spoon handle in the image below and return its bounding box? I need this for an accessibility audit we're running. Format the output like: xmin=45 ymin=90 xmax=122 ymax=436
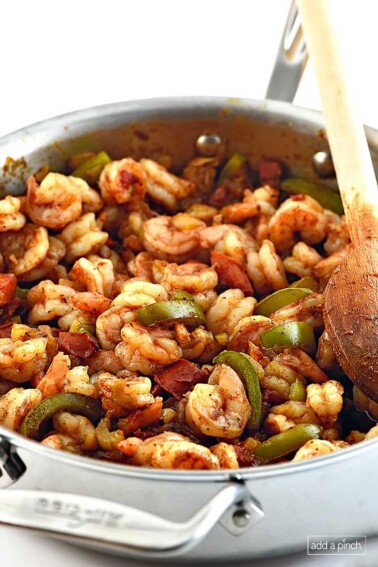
xmin=265 ymin=0 xmax=308 ymax=102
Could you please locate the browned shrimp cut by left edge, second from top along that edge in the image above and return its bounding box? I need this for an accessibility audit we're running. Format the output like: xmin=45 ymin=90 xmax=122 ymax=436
xmin=0 ymin=224 xmax=49 ymax=276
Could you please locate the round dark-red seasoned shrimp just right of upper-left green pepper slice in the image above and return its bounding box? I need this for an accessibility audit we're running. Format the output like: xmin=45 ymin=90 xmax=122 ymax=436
xmin=98 ymin=158 xmax=147 ymax=205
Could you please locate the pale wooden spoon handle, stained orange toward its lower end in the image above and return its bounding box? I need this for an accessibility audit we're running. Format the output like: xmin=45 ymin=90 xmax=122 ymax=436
xmin=297 ymin=0 xmax=378 ymax=246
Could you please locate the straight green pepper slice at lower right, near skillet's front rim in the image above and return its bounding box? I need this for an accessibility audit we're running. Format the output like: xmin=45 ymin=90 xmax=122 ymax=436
xmin=254 ymin=423 xmax=323 ymax=461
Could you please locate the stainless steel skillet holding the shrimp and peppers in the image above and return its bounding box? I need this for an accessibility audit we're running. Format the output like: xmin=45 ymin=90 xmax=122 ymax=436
xmin=0 ymin=7 xmax=378 ymax=560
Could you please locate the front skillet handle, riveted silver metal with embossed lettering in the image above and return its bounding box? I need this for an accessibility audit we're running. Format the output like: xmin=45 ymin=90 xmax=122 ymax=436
xmin=0 ymin=480 xmax=264 ymax=558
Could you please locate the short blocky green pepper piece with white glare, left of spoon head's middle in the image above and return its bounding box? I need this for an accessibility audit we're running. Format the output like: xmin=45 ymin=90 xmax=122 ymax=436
xmin=259 ymin=321 xmax=316 ymax=355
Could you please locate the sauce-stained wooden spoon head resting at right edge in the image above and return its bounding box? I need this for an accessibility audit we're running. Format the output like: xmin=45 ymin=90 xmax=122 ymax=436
xmin=324 ymin=239 xmax=378 ymax=402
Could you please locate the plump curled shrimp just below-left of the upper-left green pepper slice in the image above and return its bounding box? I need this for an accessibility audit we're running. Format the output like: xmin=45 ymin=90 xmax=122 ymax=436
xmin=26 ymin=173 xmax=82 ymax=230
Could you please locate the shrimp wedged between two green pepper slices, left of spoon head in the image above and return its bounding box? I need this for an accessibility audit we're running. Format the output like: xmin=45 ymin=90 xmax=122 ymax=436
xmin=271 ymin=293 xmax=324 ymax=328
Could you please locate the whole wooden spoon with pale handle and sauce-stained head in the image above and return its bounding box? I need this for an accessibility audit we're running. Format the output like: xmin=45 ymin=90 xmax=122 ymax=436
xmin=297 ymin=0 xmax=378 ymax=402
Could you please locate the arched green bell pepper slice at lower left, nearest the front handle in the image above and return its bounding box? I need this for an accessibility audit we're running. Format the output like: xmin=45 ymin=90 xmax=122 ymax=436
xmin=19 ymin=392 xmax=101 ymax=439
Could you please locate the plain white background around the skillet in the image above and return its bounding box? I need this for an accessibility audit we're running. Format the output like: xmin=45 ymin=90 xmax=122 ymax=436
xmin=0 ymin=0 xmax=378 ymax=567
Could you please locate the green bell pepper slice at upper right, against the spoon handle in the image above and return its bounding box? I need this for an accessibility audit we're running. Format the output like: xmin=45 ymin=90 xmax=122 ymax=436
xmin=281 ymin=177 xmax=344 ymax=215
